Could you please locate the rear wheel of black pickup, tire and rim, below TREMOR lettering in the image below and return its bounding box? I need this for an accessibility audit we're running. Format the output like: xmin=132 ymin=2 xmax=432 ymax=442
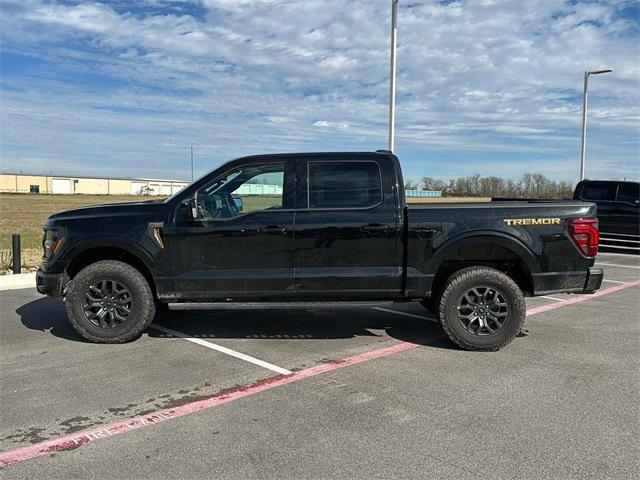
xmin=439 ymin=267 xmax=526 ymax=351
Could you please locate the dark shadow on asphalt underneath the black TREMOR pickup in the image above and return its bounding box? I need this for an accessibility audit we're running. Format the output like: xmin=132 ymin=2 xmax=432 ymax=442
xmin=16 ymin=298 xmax=456 ymax=349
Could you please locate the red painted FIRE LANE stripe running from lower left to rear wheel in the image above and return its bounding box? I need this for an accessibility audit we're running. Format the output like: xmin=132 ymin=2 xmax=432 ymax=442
xmin=0 ymin=342 xmax=418 ymax=467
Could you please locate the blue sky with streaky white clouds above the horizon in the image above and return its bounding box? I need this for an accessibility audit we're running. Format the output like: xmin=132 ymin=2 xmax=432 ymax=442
xmin=0 ymin=0 xmax=640 ymax=181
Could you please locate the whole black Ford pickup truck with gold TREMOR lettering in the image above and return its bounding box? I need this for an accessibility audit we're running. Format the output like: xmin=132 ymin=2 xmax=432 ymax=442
xmin=37 ymin=151 xmax=603 ymax=350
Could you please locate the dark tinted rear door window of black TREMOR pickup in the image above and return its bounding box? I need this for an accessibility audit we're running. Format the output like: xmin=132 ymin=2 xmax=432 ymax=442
xmin=307 ymin=161 xmax=382 ymax=208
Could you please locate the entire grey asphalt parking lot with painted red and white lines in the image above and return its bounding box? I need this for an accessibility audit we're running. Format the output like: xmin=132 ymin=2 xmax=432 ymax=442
xmin=0 ymin=254 xmax=640 ymax=479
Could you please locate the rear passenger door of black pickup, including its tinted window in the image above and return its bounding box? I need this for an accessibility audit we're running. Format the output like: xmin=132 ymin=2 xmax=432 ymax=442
xmin=294 ymin=156 xmax=402 ymax=300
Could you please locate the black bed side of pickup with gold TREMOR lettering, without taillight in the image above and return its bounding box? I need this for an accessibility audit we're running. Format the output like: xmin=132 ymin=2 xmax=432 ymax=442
xmin=405 ymin=200 xmax=596 ymax=294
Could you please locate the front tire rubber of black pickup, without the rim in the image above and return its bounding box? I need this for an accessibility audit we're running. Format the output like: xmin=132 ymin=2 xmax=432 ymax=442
xmin=65 ymin=260 xmax=156 ymax=343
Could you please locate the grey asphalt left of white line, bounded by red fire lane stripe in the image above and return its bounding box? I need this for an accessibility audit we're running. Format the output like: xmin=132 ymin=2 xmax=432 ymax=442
xmin=0 ymin=290 xmax=272 ymax=450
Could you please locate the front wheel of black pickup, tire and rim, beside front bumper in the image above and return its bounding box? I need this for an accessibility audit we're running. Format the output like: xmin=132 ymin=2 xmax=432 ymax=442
xmin=65 ymin=260 xmax=155 ymax=343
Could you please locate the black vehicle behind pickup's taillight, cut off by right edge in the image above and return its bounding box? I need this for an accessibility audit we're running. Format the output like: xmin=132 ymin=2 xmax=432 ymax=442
xmin=573 ymin=180 xmax=640 ymax=236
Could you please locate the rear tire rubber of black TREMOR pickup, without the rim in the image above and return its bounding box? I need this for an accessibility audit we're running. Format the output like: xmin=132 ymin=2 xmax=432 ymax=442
xmin=439 ymin=267 xmax=526 ymax=352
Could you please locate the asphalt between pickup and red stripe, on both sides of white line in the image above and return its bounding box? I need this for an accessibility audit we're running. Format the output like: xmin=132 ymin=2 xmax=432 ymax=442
xmin=0 ymin=289 xmax=447 ymax=450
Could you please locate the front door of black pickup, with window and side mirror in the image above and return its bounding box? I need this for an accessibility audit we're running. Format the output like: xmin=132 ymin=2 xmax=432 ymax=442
xmin=166 ymin=160 xmax=295 ymax=300
